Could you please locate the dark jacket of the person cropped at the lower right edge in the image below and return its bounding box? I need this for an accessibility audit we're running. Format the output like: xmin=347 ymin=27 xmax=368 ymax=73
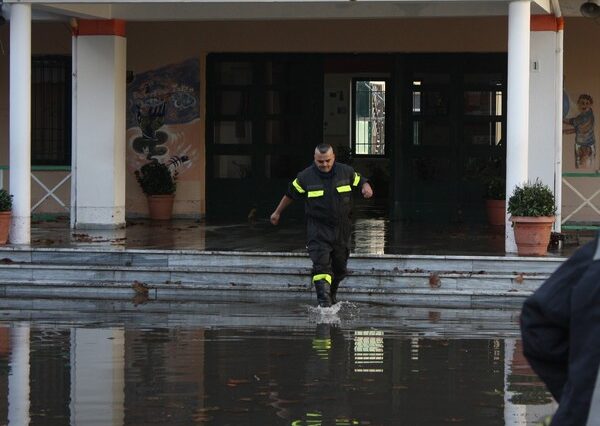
xmin=521 ymin=237 xmax=600 ymax=426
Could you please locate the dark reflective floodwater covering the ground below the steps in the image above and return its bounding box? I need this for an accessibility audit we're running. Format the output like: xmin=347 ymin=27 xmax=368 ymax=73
xmin=0 ymin=301 xmax=556 ymax=426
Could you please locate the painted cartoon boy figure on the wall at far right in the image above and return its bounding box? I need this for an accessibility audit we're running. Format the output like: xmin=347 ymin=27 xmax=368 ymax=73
xmin=563 ymin=94 xmax=596 ymax=169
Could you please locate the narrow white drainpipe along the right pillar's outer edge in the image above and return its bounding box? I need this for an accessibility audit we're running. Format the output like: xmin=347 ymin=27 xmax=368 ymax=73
xmin=552 ymin=0 xmax=564 ymax=232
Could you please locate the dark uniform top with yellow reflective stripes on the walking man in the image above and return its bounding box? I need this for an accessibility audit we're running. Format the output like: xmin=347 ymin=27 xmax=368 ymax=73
xmin=286 ymin=162 xmax=367 ymax=245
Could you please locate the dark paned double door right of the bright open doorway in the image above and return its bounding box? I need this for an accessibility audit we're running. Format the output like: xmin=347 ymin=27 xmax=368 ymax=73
xmin=392 ymin=54 xmax=506 ymax=223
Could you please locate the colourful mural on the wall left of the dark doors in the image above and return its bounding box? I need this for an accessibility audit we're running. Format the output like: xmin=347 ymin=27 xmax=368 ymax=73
xmin=127 ymin=59 xmax=200 ymax=180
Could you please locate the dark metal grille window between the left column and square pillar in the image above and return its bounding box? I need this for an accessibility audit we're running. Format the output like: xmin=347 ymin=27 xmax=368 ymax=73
xmin=31 ymin=55 xmax=71 ymax=166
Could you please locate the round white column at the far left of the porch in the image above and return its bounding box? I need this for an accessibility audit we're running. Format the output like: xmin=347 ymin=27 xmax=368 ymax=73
xmin=9 ymin=4 xmax=31 ymax=244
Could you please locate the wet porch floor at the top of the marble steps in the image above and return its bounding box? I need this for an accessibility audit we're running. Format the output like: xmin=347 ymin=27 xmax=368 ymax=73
xmin=31 ymin=217 xmax=594 ymax=257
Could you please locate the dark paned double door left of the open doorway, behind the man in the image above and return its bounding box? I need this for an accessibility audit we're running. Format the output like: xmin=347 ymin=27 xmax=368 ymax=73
xmin=206 ymin=54 xmax=323 ymax=220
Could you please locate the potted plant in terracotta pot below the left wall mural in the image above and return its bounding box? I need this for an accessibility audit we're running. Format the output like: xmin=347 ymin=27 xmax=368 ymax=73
xmin=135 ymin=159 xmax=177 ymax=220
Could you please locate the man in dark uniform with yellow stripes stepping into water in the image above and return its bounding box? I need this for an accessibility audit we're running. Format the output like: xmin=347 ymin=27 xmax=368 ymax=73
xmin=271 ymin=144 xmax=373 ymax=307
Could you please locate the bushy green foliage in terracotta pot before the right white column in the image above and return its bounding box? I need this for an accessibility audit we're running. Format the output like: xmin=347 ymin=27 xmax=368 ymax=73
xmin=508 ymin=179 xmax=556 ymax=217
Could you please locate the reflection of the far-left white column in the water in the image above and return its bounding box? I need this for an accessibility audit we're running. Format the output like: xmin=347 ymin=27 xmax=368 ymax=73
xmin=8 ymin=326 xmax=30 ymax=426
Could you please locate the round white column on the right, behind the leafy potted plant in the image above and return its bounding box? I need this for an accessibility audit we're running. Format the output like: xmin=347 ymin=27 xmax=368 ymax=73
xmin=504 ymin=0 xmax=531 ymax=253
